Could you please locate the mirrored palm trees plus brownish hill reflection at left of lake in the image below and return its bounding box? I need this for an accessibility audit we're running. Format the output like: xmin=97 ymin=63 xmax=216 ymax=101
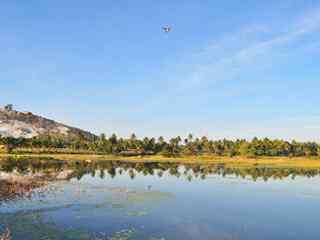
xmin=0 ymin=158 xmax=320 ymax=205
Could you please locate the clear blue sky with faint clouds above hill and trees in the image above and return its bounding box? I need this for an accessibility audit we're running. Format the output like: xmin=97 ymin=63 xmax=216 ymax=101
xmin=0 ymin=0 xmax=320 ymax=141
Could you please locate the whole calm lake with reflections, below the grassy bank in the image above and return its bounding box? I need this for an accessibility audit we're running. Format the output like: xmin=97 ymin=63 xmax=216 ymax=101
xmin=0 ymin=159 xmax=320 ymax=240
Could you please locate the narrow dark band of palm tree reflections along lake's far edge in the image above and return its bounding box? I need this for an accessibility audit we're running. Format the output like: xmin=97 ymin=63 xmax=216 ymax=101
xmin=0 ymin=159 xmax=320 ymax=181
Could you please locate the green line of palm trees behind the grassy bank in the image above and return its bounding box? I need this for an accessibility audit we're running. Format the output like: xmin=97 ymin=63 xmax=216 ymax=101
xmin=0 ymin=134 xmax=320 ymax=157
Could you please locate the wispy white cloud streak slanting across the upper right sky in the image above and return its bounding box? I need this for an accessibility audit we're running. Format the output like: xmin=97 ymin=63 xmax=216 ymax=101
xmin=181 ymin=9 xmax=320 ymax=88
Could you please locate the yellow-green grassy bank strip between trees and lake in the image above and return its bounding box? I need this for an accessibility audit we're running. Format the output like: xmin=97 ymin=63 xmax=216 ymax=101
xmin=0 ymin=153 xmax=320 ymax=169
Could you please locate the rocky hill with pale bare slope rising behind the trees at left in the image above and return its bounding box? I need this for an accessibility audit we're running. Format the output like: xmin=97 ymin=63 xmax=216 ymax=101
xmin=0 ymin=105 xmax=95 ymax=140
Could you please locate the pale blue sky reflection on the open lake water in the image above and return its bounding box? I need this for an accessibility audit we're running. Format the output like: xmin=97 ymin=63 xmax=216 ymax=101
xmin=0 ymin=173 xmax=320 ymax=240
